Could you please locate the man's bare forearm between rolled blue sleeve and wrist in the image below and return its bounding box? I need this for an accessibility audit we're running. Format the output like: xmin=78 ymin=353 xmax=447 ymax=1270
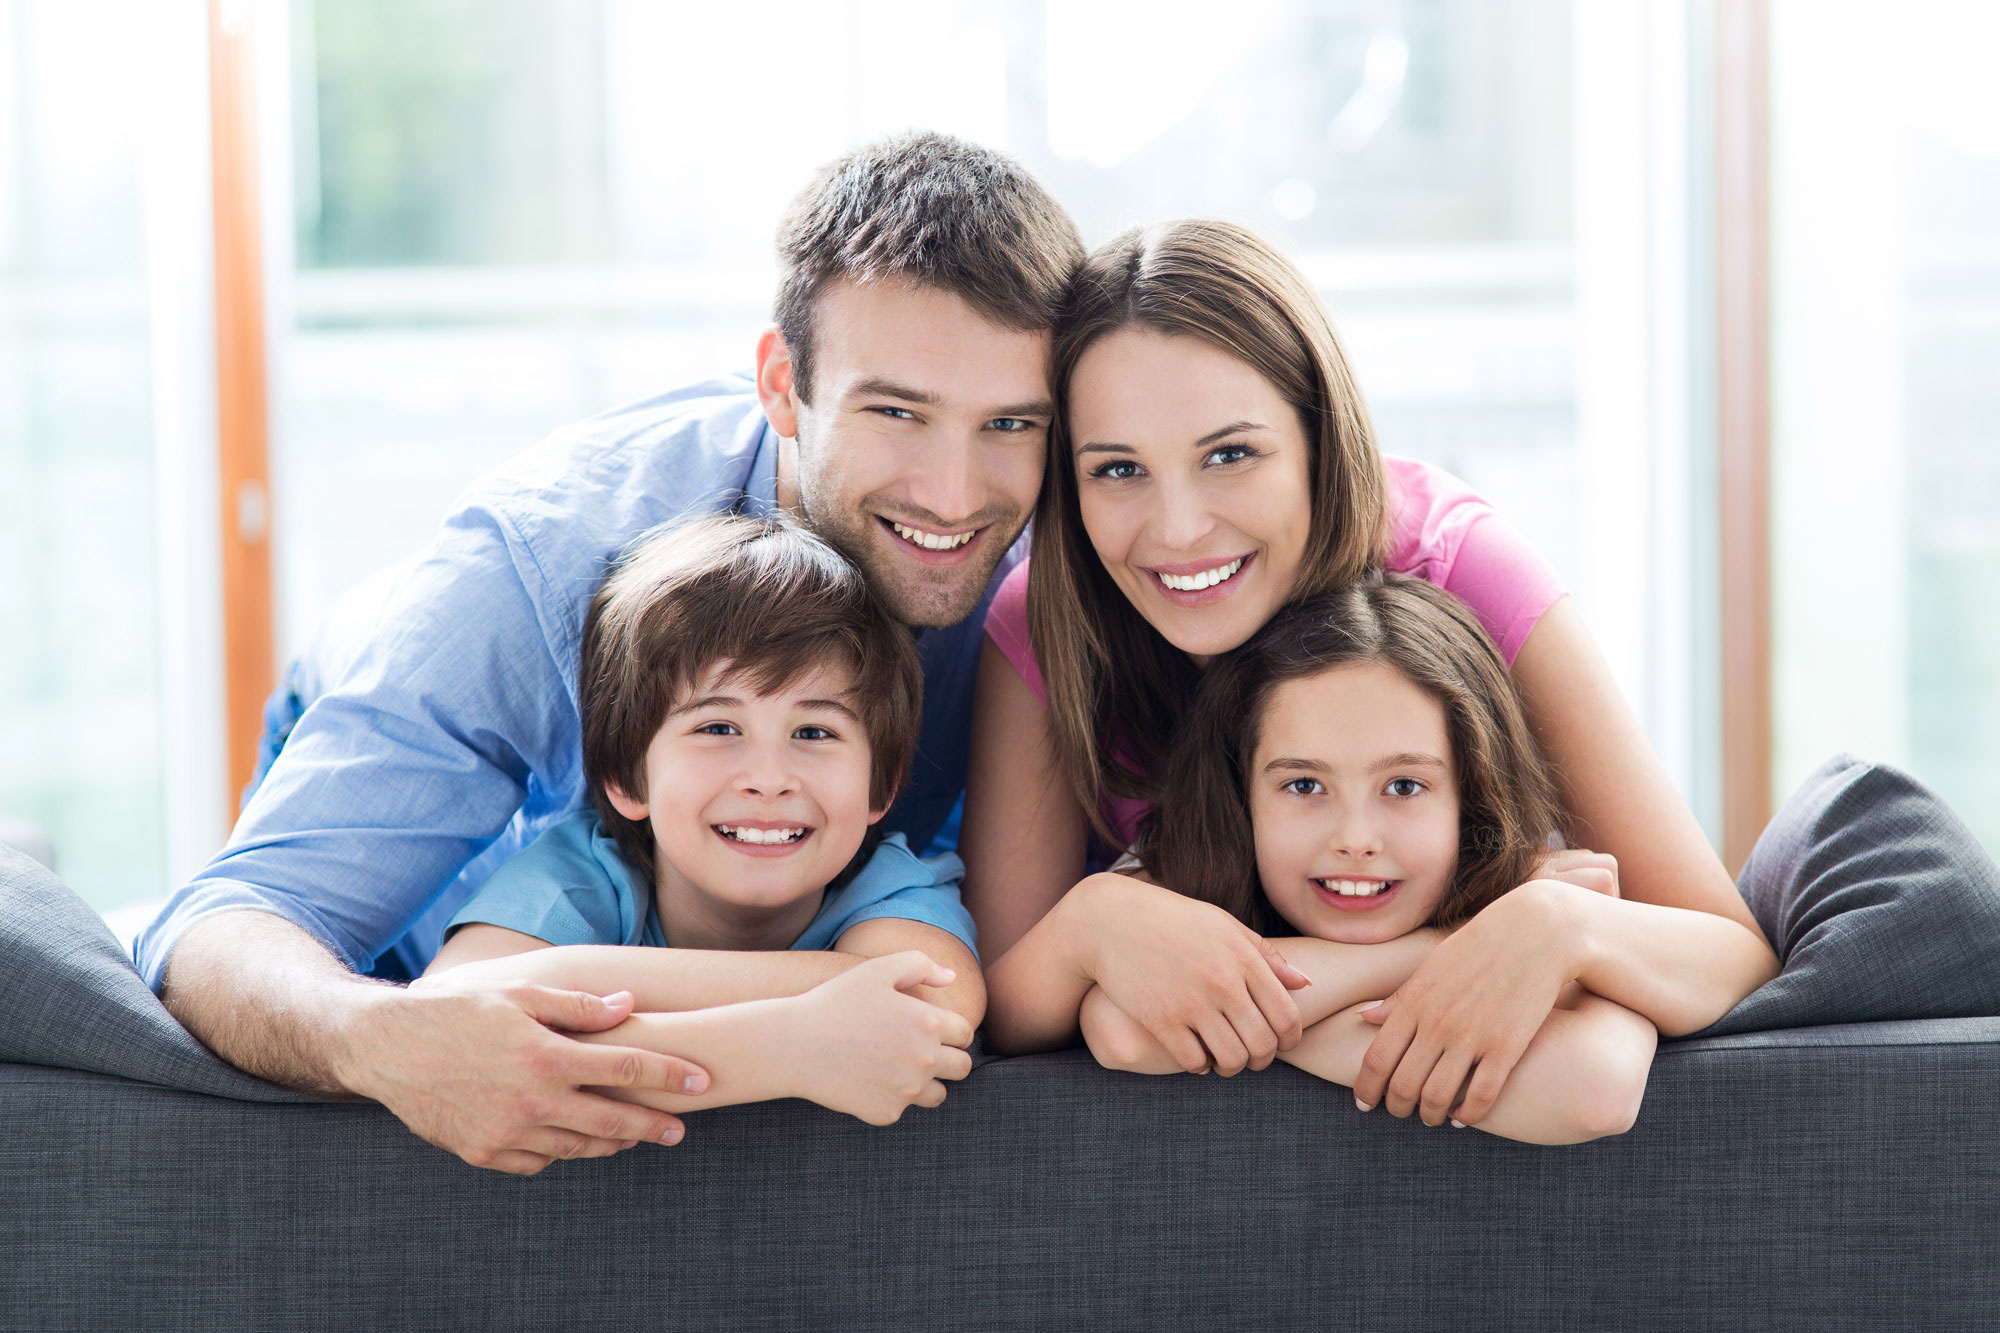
xmin=160 ymin=911 xmax=394 ymax=1097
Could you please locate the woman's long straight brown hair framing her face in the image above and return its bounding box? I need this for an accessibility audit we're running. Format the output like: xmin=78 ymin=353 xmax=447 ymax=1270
xmin=1028 ymin=218 xmax=1388 ymax=839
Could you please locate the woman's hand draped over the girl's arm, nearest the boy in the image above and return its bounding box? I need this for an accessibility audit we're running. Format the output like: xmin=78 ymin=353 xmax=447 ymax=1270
xmin=1064 ymin=875 xmax=1312 ymax=1077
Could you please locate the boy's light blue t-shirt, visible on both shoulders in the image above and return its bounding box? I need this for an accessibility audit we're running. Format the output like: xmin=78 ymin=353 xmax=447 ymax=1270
xmin=446 ymin=811 xmax=978 ymax=957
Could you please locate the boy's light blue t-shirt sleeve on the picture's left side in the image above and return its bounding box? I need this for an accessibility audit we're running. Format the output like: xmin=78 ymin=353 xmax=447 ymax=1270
xmin=446 ymin=813 xmax=652 ymax=945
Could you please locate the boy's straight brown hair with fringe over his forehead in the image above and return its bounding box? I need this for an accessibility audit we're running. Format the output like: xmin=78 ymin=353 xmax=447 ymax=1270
xmin=576 ymin=514 xmax=924 ymax=881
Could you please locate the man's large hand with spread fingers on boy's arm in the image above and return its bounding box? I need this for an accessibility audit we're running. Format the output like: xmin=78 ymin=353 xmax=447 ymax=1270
xmin=352 ymin=969 xmax=708 ymax=1175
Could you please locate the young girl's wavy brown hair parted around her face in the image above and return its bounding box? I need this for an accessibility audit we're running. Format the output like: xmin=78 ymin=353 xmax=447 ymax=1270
xmin=1140 ymin=574 xmax=1560 ymax=935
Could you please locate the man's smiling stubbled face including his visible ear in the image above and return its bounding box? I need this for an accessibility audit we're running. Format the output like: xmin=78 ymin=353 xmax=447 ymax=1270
xmin=758 ymin=282 xmax=1054 ymax=626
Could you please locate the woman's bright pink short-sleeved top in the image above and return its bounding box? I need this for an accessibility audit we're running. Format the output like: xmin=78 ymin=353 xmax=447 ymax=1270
xmin=986 ymin=458 xmax=1564 ymax=847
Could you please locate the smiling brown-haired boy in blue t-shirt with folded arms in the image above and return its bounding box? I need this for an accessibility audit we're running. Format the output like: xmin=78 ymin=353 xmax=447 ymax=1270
xmin=418 ymin=516 xmax=978 ymax=1125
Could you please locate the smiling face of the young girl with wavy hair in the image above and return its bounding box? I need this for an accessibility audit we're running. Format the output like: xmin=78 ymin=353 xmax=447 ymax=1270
xmin=1246 ymin=662 xmax=1458 ymax=945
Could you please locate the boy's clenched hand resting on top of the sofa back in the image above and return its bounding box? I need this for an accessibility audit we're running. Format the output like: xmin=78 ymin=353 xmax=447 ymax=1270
xmin=782 ymin=951 xmax=972 ymax=1125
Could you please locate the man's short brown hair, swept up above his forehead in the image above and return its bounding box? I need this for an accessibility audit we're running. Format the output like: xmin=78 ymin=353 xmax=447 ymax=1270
xmin=774 ymin=132 xmax=1084 ymax=402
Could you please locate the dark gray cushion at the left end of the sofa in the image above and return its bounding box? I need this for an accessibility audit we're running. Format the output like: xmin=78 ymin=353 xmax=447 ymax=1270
xmin=0 ymin=847 xmax=312 ymax=1101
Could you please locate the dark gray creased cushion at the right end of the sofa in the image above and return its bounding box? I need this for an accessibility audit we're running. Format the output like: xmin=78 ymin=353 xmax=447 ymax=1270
xmin=1696 ymin=755 xmax=2000 ymax=1037
